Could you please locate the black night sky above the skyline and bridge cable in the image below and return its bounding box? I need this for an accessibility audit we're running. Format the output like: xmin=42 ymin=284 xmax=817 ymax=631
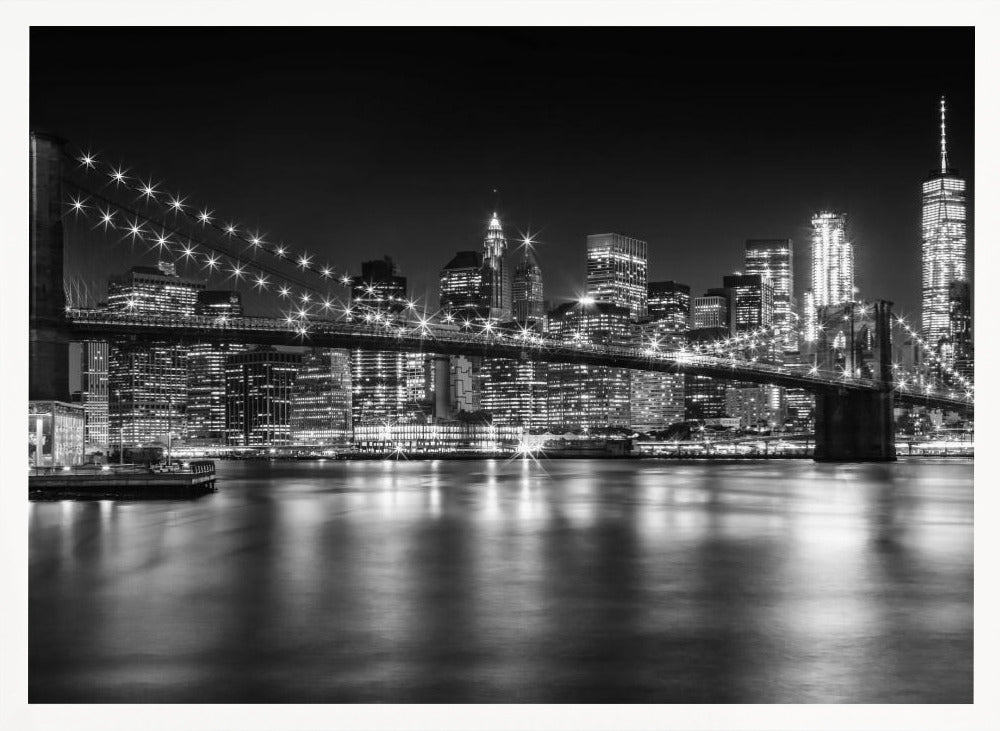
xmin=30 ymin=28 xmax=974 ymax=314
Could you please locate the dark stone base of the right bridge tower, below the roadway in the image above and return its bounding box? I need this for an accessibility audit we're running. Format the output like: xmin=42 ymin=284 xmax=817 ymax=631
xmin=813 ymin=389 xmax=896 ymax=462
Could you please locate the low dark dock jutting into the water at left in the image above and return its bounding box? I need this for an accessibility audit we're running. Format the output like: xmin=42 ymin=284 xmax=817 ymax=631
xmin=28 ymin=460 xmax=215 ymax=500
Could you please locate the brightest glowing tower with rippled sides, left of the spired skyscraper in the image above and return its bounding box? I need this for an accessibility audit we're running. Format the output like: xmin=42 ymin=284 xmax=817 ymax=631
xmin=803 ymin=211 xmax=855 ymax=340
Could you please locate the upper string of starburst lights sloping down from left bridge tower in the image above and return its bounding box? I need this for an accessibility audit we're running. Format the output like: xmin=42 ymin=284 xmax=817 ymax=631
xmin=76 ymin=151 xmax=351 ymax=286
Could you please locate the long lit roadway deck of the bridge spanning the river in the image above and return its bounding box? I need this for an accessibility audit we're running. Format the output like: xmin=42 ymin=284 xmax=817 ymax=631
xmin=66 ymin=309 xmax=973 ymax=413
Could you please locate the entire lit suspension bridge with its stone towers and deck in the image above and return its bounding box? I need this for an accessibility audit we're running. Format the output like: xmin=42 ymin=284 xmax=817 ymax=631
xmin=29 ymin=135 xmax=972 ymax=460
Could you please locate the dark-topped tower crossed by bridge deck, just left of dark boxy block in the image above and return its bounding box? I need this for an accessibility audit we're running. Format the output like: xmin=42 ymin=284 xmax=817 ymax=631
xmin=186 ymin=289 xmax=246 ymax=446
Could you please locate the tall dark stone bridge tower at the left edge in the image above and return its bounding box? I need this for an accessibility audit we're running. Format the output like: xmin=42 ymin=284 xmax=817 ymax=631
xmin=28 ymin=133 xmax=70 ymax=401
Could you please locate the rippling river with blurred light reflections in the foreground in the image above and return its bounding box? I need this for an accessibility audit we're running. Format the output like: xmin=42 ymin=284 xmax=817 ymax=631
xmin=29 ymin=459 xmax=973 ymax=703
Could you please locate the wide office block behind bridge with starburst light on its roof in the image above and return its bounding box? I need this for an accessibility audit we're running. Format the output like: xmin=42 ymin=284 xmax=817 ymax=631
xmin=548 ymin=300 xmax=637 ymax=429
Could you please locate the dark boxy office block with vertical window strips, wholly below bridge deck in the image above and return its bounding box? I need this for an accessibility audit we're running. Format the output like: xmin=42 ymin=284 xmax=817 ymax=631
xmin=226 ymin=347 xmax=302 ymax=447
